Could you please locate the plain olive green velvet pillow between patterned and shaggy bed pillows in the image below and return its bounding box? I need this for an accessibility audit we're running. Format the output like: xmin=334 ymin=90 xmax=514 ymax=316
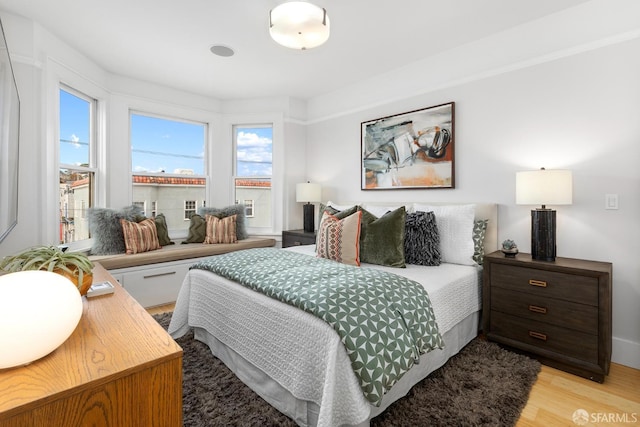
xmin=358 ymin=206 xmax=407 ymax=268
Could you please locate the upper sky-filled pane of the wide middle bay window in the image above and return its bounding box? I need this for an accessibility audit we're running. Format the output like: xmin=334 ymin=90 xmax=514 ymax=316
xmin=131 ymin=114 xmax=206 ymax=175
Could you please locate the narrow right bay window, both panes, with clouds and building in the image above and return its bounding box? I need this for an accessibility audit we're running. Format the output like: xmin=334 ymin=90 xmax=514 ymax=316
xmin=233 ymin=124 xmax=273 ymax=229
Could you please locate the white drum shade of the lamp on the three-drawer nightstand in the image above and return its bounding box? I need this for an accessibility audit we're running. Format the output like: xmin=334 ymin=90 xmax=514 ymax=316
xmin=516 ymin=169 xmax=573 ymax=205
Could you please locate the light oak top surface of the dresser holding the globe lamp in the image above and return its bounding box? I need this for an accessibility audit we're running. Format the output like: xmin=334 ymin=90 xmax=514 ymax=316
xmin=0 ymin=264 xmax=182 ymax=413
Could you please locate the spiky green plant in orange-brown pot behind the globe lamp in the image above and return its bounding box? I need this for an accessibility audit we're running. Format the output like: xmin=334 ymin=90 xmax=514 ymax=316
xmin=0 ymin=246 xmax=93 ymax=295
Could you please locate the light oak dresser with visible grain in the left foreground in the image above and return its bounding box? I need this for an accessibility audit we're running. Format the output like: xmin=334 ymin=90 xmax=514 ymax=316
xmin=0 ymin=264 xmax=182 ymax=427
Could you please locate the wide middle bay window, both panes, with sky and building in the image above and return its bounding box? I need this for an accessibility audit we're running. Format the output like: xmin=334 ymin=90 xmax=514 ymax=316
xmin=130 ymin=112 xmax=207 ymax=234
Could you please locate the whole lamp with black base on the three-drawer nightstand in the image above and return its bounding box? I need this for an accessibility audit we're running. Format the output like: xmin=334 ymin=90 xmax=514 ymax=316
xmin=516 ymin=168 xmax=573 ymax=261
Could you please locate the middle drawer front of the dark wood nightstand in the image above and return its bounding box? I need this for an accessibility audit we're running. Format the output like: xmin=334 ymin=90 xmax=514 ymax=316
xmin=491 ymin=288 xmax=598 ymax=335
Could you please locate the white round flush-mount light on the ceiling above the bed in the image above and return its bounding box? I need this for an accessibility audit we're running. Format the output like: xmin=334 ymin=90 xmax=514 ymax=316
xmin=269 ymin=1 xmax=329 ymax=50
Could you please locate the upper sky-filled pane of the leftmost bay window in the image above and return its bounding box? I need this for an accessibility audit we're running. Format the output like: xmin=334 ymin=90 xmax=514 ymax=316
xmin=60 ymin=89 xmax=91 ymax=166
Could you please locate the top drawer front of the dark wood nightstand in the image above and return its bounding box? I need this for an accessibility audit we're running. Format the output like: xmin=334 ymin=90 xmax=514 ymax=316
xmin=491 ymin=264 xmax=598 ymax=306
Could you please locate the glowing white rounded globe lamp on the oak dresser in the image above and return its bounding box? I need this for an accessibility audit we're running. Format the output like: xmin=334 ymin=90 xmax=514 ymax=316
xmin=0 ymin=271 xmax=82 ymax=369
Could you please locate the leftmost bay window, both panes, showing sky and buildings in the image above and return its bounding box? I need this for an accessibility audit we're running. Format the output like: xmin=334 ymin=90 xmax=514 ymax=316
xmin=58 ymin=86 xmax=97 ymax=244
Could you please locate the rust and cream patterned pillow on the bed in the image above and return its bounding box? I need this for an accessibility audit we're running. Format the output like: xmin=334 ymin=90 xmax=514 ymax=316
xmin=316 ymin=211 xmax=362 ymax=265
